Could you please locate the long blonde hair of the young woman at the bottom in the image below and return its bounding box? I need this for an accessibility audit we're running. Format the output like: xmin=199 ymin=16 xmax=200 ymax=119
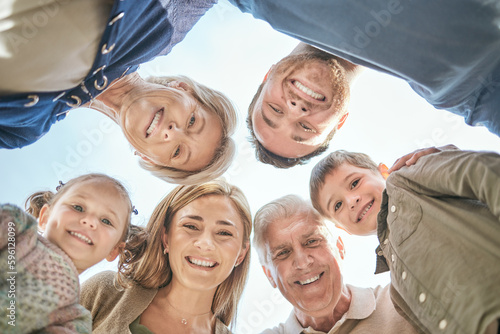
xmin=117 ymin=180 xmax=252 ymax=325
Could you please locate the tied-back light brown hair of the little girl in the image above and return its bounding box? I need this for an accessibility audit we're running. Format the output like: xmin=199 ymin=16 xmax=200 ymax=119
xmin=24 ymin=173 xmax=133 ymax=241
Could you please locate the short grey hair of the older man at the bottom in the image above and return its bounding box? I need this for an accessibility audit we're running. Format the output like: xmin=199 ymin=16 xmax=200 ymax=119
xmin=252 ymin=195 xmax=339 ymax=265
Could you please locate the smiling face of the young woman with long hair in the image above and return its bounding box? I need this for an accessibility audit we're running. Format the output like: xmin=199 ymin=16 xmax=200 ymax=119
xmin=163 ymin=195 xmax=248 ymax=292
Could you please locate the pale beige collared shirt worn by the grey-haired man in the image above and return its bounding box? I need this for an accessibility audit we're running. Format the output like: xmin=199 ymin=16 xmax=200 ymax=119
xmin=262 ymin=285 xmax=418 ymax=334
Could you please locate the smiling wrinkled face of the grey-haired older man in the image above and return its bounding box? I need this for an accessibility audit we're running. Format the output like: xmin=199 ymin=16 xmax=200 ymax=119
xmin=264 ymin=214 xmax=342 ymax=314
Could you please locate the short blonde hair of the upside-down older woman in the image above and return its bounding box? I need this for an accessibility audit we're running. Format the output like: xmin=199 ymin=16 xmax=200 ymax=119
xmin=139 ymin=76 xmax=237 ymax=185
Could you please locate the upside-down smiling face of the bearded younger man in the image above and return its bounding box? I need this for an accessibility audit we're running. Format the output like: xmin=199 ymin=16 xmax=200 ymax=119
xmin=251 ymin=55 xmax=349 ymax=158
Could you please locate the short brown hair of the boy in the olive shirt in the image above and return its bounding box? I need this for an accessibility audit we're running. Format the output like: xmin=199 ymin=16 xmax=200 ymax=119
xmin=309 ymin=150 xmax=378 ymax=217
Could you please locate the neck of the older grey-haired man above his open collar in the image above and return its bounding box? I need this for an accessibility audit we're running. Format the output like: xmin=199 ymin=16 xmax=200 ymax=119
xmin=294 ymin=286 xmax=351 ymax=333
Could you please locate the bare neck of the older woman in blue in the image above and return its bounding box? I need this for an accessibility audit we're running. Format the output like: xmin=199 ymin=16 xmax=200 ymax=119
xmin=86 ymin=72 xmax=144 ymax=124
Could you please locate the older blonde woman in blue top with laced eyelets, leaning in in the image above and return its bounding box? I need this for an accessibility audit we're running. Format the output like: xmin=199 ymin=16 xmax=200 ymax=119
xmin=0 ymin=0 xmax=236 ymax=184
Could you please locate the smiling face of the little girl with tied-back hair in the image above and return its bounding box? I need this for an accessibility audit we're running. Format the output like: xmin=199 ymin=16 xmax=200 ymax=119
xmin=38 ymin=179 xmax=129 ymax=273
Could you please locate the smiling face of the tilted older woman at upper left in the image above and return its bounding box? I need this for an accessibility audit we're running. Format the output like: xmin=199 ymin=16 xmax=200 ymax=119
xmin=121 ymin=83 xmax=222 ymax=171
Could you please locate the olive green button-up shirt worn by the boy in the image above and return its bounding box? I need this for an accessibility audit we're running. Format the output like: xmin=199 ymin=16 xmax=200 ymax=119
xmin=377 ymin=150 xmax=500 ymax=334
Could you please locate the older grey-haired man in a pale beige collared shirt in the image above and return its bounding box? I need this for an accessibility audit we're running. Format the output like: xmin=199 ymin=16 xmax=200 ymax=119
xmin=253 ymin=195 xmax=418 ymax=334
